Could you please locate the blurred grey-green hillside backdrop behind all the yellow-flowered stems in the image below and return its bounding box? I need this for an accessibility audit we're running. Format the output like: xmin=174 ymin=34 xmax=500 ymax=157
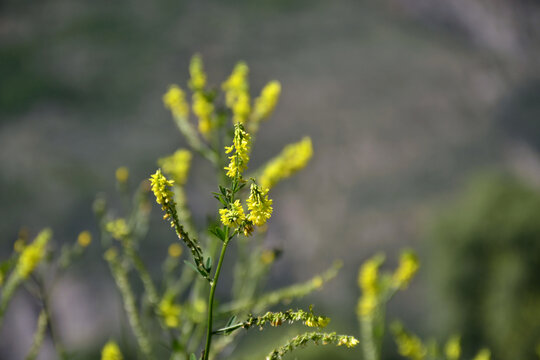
xmin=0 ymin=0 xmax=540 ymax=360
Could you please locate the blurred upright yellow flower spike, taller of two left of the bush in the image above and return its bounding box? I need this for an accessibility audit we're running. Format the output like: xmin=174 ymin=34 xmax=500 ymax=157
xmin=357 ymin=254 xmax=384 ymax=316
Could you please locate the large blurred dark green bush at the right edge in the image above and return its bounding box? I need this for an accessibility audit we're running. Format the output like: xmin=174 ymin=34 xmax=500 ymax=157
xmin=426 ymin=174 xmax=540 ymax=360
